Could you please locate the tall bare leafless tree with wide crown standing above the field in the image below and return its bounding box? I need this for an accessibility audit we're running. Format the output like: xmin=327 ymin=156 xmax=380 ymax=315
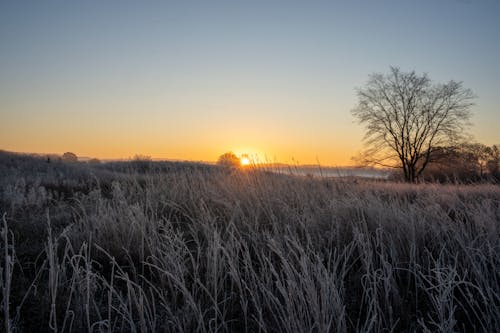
xmin=352 ymin=67 xmax=474 ymax=182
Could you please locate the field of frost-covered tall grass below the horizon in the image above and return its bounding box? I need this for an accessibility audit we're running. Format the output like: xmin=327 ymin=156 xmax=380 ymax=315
xmin=0 ymin=153 xmax=500 ymax=332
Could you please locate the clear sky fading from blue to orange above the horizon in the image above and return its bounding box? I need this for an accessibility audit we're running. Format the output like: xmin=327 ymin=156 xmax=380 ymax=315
xmin=0 ymin=0 xmax=500 ymax=166
